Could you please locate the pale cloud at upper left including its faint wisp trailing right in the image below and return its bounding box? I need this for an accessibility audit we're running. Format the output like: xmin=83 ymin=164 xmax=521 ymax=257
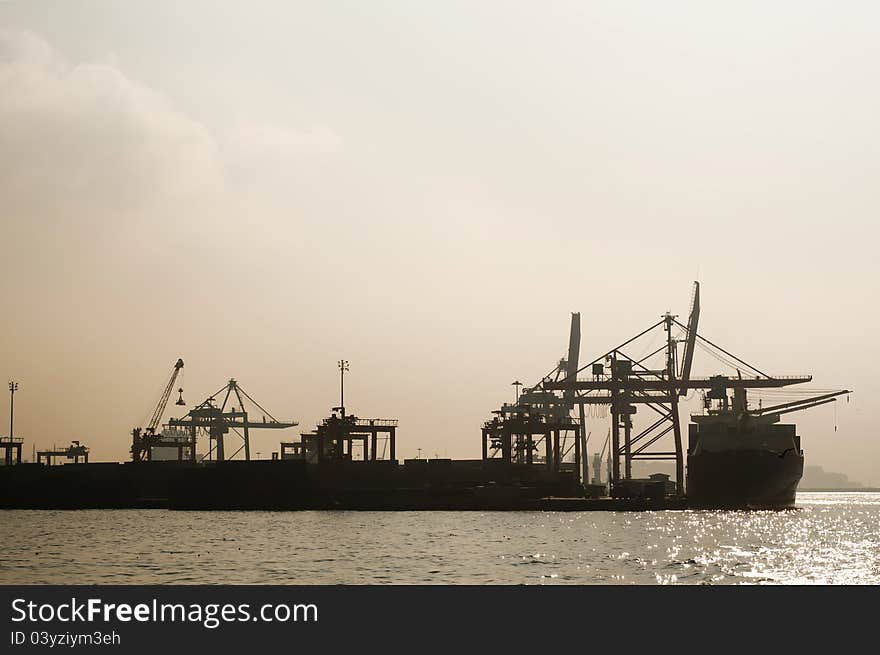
xmin=0 ymin=29 xmax=343 ymax=238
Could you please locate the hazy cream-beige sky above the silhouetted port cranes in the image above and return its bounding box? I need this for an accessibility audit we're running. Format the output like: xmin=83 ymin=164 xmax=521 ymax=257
xmin=0 ymin=0 xmax=880 ymax=485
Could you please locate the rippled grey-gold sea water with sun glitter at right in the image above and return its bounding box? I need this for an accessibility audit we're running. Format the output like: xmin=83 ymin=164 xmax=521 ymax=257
xmin=0 ymin=493 xmax=880 ymax=584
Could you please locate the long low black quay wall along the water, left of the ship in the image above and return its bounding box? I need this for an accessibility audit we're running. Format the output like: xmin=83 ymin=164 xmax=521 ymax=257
xmin=0 ymin=460 xmax=582 ymax=510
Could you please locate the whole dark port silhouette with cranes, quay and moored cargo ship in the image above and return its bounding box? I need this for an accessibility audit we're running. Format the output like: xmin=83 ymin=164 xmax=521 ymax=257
xmin=0 ymin=283 xmax=848 ymax=510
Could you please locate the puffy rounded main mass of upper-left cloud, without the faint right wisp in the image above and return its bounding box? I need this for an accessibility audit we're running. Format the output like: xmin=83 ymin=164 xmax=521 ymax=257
xmin=0 ymin=30 xmax=218 ymax=217
